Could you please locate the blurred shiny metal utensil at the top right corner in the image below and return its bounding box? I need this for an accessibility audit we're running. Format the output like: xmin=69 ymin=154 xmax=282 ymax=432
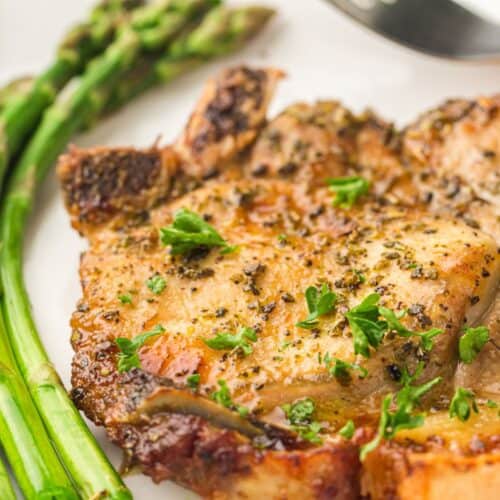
xmin=328 ymin=0 xmax=500 ymax=60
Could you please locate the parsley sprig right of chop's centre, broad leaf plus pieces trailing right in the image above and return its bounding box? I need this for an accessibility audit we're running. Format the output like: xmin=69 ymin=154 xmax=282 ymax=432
xmin=345 ymin=293 xmax=443 ymax=358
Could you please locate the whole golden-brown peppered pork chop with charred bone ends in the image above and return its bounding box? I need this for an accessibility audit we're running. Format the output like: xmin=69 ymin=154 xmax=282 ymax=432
xmin=60 ymin=68 xmax=500 ymax=500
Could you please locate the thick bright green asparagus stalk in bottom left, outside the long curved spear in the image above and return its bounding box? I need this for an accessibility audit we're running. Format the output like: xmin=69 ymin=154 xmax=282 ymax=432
xmin=0 ymin=311 xmax=76 ymax=500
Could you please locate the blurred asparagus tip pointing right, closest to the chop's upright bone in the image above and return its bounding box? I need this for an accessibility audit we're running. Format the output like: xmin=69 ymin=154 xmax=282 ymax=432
xmin=105 ymin=6 xmax=274 ymax=113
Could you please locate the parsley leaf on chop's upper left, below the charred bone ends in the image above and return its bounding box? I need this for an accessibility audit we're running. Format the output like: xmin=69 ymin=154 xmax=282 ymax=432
xmin=160 ymin=208 xmax=237 ymax=255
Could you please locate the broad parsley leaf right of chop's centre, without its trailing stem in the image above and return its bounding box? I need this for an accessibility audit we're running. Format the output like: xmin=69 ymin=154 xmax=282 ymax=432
xmin=345 ymin=293 xmax=387 ymax=358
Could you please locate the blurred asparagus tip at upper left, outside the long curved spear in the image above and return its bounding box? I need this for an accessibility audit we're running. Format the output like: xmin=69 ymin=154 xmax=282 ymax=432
xmin=0 ymin=0 xmax=143 ymax=185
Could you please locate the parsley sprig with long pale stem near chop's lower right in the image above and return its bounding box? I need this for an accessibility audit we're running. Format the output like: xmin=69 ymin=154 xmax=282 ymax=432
xmin=360 ymin=374 xmax=441 ymax=461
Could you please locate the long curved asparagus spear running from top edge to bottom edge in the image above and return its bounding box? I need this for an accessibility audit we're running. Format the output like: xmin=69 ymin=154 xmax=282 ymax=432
xmin=0 ymin=0 xmax=218 ymax=499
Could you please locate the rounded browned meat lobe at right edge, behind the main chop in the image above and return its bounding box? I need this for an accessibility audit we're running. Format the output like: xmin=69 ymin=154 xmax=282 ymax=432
xmin=402 ymin=96 xmax=500 ymax=241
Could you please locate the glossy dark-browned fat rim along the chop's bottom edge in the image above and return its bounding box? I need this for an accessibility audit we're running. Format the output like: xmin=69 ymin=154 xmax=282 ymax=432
xmin=107 ymin=414 xmax=361 ymax=499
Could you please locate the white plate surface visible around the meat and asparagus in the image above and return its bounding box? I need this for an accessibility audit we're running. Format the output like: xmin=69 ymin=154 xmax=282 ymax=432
xmin=0 ymin=0 xmax=500 ymax=500
